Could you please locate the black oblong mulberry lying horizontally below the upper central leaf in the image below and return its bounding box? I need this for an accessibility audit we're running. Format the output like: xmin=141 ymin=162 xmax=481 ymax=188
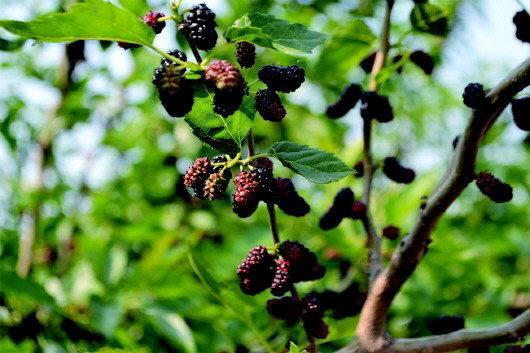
xmin=258 ymin=65 xmax=305 ymax=93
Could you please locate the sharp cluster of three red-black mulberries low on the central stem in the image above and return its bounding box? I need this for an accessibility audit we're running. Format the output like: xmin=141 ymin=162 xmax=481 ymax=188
xmin=237 ymin=240 xmax=326 ymax=296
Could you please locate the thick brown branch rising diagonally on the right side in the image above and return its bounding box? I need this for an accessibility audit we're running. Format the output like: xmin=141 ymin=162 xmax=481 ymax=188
xmin=350 ymin=55 xmax=530 ymax=351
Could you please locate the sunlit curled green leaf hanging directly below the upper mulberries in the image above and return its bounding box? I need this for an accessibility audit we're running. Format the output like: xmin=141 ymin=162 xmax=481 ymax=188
xmin=184 ymin=84 xmax=256 ymax=154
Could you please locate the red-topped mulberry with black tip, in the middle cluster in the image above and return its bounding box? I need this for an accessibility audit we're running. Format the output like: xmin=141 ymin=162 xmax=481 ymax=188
xmin=232 ymin=170 xmax=259 ymax=218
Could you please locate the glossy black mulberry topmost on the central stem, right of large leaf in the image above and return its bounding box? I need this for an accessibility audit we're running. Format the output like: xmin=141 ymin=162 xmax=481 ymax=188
xmin=178 ymin=4 xmax=217 ymax=50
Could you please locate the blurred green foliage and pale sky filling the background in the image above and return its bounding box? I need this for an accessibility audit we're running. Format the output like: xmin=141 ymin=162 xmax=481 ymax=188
xmin=0 ymin=0 xmax=530 ymax=353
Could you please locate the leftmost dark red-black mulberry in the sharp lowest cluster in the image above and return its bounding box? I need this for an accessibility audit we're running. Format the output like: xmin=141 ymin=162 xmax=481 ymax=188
xmin=237 ymin=245 xmax=275 ymax=295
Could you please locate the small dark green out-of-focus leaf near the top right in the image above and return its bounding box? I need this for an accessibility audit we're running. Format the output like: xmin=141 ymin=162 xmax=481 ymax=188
xmin=410 ymin=3 xmax=449 ymax=37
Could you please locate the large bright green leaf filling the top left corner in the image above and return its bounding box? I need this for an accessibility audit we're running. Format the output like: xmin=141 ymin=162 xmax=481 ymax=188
xmin=0 ymin=0 xmax=155 ymax=46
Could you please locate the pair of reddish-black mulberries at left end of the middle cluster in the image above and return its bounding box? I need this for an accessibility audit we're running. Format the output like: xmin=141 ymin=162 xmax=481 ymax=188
xmin=184 ymin=155 xmax=232 ymax=200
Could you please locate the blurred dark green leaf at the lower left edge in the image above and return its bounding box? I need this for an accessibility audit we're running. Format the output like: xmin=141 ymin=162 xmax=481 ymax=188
xmin=0 ymin=269 xmax=58 ymax=310
